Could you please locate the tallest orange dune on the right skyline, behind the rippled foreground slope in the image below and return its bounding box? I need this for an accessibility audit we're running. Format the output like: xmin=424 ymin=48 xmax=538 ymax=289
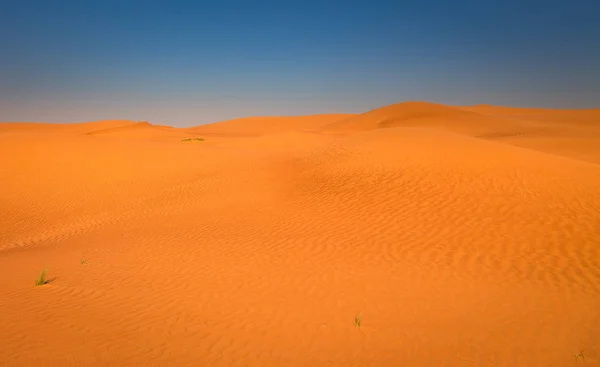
xmin=321 ymin=102 xmax=600 ymax=164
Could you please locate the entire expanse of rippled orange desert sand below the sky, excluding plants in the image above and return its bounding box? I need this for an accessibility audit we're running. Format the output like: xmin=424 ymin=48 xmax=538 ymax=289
xmin=0 ymin=102 xmax=600 ymax=367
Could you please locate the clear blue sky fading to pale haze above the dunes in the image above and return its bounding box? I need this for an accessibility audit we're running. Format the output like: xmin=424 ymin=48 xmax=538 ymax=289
xmin=0 ymin=0 xmax=600 ymax=126
